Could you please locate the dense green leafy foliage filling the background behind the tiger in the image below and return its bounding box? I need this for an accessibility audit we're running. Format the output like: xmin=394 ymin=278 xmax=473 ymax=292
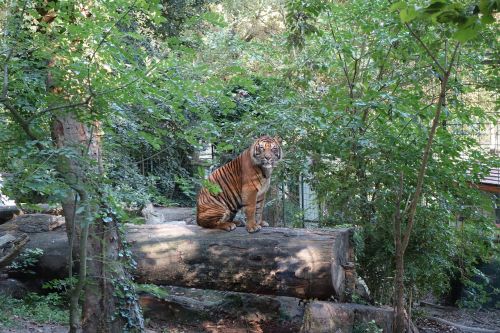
xmin=0 ymin=0 xmax=498 ymax=320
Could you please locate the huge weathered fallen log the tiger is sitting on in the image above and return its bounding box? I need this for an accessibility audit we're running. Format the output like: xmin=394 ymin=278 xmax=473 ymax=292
xmin=21 ymin=224 xmax=355 ymax=301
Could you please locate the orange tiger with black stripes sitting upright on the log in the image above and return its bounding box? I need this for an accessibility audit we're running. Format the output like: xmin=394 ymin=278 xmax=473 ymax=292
xmin=196 ymin=135 xmax=283 ymax=233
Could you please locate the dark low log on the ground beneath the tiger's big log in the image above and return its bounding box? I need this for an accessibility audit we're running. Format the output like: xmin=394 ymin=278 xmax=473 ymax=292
xmin=139 ymin=286 xmax=306 ymax=332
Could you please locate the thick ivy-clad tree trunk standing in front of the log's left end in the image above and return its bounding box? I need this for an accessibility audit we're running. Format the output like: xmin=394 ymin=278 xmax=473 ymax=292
xmin=52 ymin=113 xmax=130 ymax=332
